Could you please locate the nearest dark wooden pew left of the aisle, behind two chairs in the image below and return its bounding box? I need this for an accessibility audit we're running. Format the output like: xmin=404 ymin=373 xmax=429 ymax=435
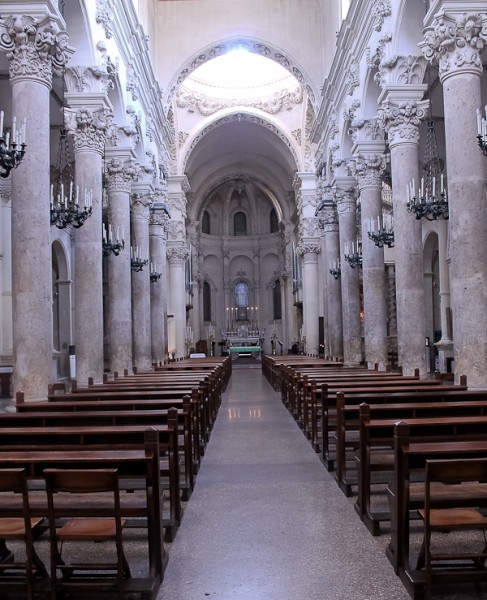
xmin=0 ymin=431 xmax=168 ymax=600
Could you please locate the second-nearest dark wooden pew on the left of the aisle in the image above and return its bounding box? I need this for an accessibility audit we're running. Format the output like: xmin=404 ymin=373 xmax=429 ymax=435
xmin=0 ymin=425 xmax=182 ymax=541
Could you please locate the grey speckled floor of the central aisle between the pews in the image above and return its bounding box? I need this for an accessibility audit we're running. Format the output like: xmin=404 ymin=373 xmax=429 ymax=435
xmin=158 ymin=368 xmax=409 ymax=600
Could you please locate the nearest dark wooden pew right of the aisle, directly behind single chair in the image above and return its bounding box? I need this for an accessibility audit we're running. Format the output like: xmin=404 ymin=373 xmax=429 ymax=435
xmin=386 ymin=422 xmax=487 ymax=600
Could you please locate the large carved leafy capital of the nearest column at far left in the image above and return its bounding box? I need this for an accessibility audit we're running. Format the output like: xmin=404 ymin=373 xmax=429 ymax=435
xmin=0 ymin=15 xmax=74 ymax=88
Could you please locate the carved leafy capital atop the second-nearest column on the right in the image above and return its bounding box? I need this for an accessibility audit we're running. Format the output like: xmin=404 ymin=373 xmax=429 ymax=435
xmin=377 ymin=100 xmax=428 ymax=146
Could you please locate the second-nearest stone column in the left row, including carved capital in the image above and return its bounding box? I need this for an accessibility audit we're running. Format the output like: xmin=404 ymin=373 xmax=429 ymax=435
xmin=66 ymin=94 xmax=109 ymax=386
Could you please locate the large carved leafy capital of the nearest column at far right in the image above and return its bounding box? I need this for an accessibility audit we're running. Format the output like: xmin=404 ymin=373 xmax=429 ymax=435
xmin=419 ymin=13 xmax=487 ymax=81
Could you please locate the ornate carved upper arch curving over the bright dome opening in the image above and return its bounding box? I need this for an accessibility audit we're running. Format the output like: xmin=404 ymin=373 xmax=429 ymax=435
xmin=163 ymin=38 xmax=320 ymax=115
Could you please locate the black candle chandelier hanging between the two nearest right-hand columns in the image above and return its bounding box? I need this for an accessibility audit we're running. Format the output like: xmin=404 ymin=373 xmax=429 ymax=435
xmin=406 ymin=118 xmax=449 ymax=221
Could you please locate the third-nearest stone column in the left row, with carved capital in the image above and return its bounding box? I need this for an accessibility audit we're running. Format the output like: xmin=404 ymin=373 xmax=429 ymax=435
xmin=105 ymin=148 xmax=138 ymax=373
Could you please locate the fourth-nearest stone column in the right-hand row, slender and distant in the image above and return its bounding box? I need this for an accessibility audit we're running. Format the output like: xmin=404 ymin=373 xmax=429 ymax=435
xmin=335 ymin=177 xmax=362 ymax=365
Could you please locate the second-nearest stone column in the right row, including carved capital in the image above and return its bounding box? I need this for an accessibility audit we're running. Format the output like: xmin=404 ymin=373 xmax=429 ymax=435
xmin=378 ymin=95 xmax=426 ymax=375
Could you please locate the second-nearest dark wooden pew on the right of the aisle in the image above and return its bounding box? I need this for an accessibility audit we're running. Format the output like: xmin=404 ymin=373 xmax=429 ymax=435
xmin=355 ymin=401 xmax=487 ymax=535
